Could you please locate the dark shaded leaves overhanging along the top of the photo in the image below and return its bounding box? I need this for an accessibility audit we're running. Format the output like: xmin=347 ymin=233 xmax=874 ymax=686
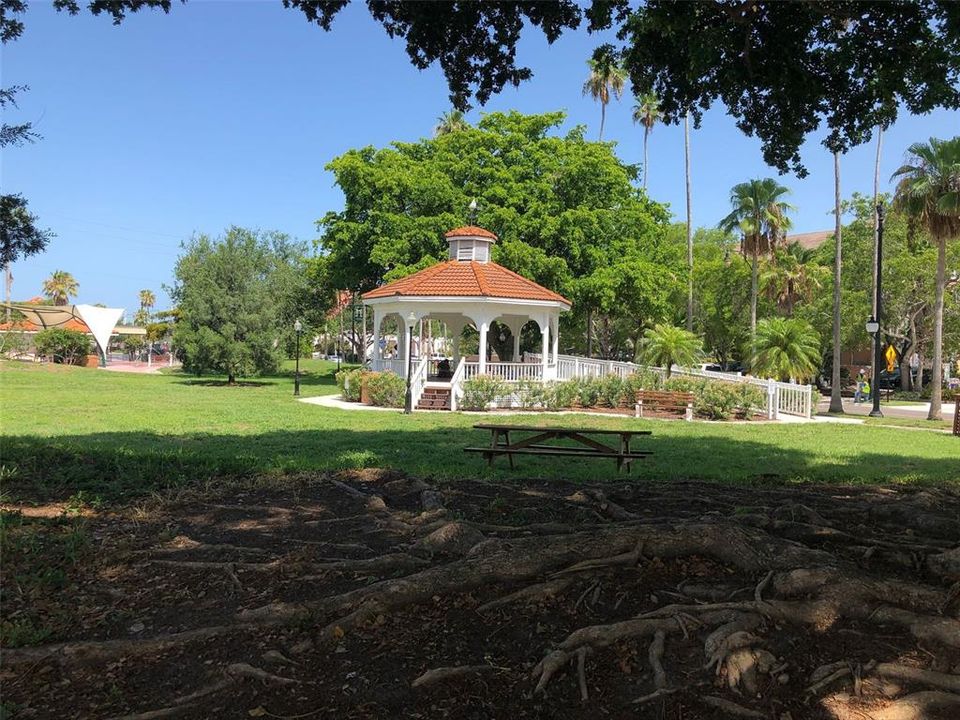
xmin=9 ymin=0 xmax=960 ymax=176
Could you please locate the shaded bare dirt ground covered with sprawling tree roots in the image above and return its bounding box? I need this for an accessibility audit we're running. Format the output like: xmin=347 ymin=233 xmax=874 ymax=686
xmin=0 ymin=471 xmax=960 ymax=720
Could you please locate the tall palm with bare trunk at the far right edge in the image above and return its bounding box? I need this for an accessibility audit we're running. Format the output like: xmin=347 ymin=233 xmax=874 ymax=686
xmin=893 ymin=136 xmax=960 ymax=420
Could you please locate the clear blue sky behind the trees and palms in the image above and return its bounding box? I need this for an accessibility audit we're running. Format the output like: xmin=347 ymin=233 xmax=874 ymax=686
xmin=0 ymin=0 xmax=960 ymax=308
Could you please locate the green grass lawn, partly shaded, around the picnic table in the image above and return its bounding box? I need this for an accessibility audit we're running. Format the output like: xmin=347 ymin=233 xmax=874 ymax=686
xmin=0 ymin=361 xmax=960 ymax=502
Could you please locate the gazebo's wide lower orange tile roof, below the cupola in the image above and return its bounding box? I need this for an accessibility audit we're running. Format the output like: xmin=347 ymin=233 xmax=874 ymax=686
xmin=363 ymin=260 xmax=571 ymax=305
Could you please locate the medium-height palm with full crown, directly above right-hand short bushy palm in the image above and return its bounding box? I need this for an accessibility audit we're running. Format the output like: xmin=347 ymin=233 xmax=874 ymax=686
xmin=719 ymin=178 xmax=794 ymax=339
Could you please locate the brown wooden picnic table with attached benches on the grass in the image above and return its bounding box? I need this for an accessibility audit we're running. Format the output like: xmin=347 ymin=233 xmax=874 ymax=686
xmin=464 ymin=423 xmax=653 ymax=472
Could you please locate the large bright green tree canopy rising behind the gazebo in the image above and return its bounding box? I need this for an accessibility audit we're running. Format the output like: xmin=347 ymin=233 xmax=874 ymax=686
xmin=312 ymin=112 xmax=686 ymax=358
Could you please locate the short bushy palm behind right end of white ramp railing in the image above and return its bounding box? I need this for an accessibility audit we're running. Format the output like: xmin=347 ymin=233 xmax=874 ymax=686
xmin=750 ymin=318 xmax=820 ymax=382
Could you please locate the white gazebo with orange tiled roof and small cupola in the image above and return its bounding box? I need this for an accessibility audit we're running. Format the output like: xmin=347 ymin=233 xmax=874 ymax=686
xmin=363 ymin=225 xmax=570 ymax=407
